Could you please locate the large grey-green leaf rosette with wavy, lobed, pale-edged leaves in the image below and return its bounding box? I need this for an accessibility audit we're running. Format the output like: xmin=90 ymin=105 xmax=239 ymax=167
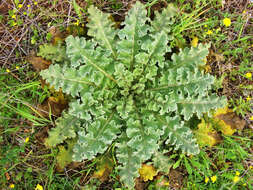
xmin=41 ymin=2 xmax=225 ymax=189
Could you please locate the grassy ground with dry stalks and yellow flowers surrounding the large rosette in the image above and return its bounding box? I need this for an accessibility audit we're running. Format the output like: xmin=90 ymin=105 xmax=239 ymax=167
xmin=0 ymin=0 xmax=253 ymax=190
